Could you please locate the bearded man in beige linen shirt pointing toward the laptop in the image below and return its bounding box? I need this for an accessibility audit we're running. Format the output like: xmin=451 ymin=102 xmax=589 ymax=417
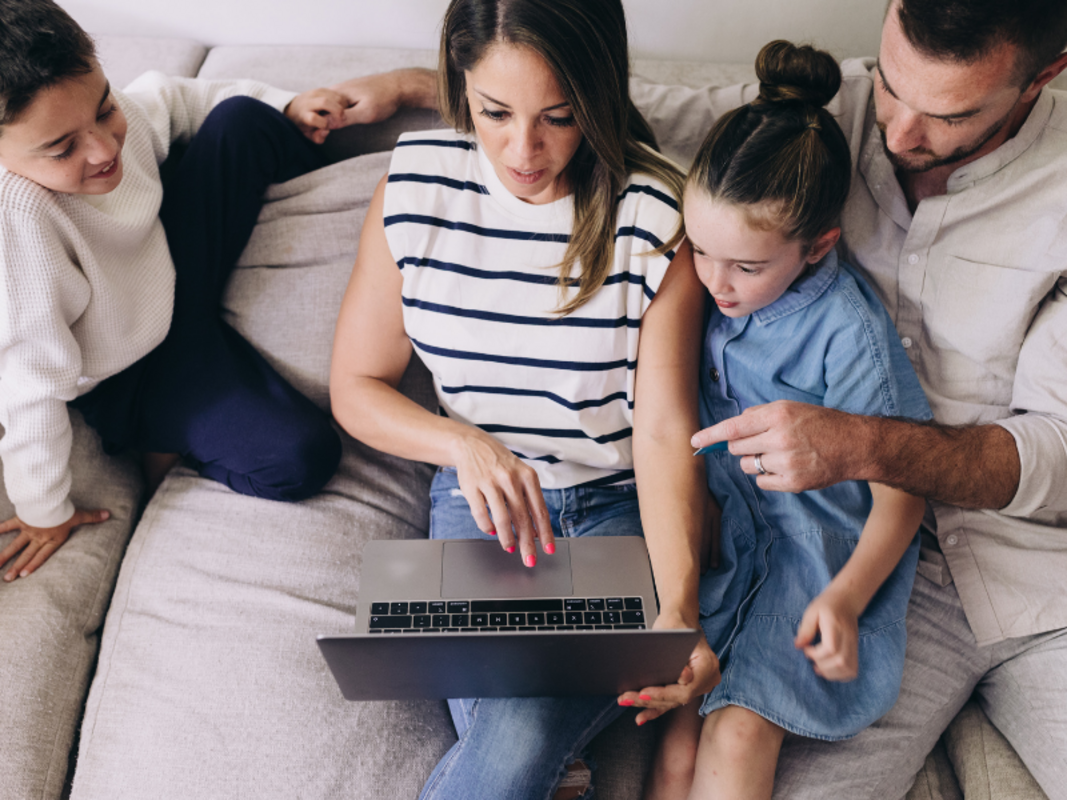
xmin=362 ymin=0 xmax=1067 ymax=799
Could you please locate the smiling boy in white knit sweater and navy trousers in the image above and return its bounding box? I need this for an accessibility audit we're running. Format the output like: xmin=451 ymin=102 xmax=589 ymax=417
xmin=0 ymin=0 xmax=394 ymax=581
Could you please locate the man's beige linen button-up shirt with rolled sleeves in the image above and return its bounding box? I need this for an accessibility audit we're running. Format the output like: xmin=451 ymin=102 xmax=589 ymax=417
xmin=632 ymin=59 xmax=1067 ymax=644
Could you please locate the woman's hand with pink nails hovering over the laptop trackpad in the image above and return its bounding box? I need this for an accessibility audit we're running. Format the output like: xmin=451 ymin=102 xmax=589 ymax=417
xmin=455 ymin=429 xmax=556 ymax=566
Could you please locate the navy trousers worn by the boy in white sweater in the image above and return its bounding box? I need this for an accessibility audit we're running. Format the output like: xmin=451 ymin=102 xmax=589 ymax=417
xmin=71 ymin=97 xmax=340 ymax=500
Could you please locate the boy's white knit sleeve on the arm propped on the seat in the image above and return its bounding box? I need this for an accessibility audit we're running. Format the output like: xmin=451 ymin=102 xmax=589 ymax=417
xmin=0 ymin=211 xmax=82 ymax=528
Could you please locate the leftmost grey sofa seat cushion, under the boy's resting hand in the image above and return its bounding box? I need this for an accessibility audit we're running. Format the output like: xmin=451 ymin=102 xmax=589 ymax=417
xmin=0 ymin=412 xmax=141 ymax=798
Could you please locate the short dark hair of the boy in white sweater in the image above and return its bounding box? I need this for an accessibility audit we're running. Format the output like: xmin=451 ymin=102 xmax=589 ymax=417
xmin=0 ymin=0 xmax=96 ymax=130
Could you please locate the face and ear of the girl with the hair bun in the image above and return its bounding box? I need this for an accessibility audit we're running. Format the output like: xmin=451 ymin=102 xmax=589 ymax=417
xmin=684 ymin=190 xmax=841 ymax=317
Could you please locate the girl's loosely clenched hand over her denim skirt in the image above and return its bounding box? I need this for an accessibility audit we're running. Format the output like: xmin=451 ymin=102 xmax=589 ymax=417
xmin=794 ymin=591 xmax=860 ymax=682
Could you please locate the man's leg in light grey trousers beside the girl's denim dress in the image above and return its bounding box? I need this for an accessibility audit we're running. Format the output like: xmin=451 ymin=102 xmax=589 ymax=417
xmin=775 ymin=575 xmax=991 ymax=800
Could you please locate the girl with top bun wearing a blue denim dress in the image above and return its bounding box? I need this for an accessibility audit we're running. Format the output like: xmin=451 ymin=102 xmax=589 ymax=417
xmin=647 ymin=42 xmax=929 ymax=800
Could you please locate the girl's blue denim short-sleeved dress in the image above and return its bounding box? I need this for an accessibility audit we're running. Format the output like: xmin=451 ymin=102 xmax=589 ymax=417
xmin=700 ymin=252 xmax=930 ymax=740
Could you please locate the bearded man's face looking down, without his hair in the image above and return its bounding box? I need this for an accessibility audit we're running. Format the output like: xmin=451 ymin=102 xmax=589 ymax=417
xmin=874 ymin=3 xmax=1032 ymax=173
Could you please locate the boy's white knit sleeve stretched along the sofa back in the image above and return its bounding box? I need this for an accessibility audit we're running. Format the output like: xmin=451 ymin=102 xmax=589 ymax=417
xmin=124 ymin=71 xmax=297 ymax=160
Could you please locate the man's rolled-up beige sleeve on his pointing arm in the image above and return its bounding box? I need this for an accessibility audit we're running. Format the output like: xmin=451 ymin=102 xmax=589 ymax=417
xmin=998 ymin=277 xmax=1067 ymax=526
